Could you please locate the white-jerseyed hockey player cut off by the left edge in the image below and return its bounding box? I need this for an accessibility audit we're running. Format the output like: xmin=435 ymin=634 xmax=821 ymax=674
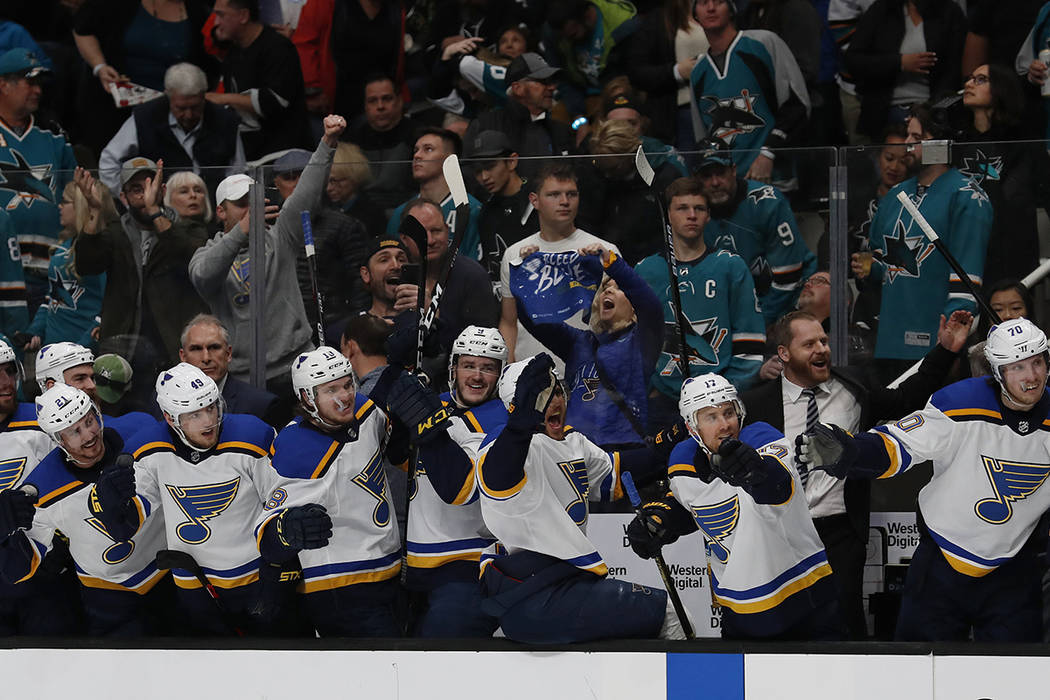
xmin=0 ymin=340 xmax=80 ymax=636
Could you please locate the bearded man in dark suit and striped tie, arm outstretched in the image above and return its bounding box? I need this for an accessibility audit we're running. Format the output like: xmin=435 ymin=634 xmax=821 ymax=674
xmin=741 ymin=311 xmax=973 ymax=639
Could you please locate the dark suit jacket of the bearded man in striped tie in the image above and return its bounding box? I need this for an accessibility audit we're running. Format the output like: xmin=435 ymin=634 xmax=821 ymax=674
xmin=740 ymin=345 xmax=957 ymax=542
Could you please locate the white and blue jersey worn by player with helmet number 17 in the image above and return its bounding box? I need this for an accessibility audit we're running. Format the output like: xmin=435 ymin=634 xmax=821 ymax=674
xmin=668 ymin=423 xmax=834 ymax=635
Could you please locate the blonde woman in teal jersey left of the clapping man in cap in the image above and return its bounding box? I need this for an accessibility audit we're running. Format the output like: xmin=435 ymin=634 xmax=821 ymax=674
xmin=23 ymin=168 xmax=119 ymax=352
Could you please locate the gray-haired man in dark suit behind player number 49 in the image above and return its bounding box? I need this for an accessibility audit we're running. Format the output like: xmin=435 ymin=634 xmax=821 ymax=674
xmin=179 ymin=314 xmax=291 ymax=430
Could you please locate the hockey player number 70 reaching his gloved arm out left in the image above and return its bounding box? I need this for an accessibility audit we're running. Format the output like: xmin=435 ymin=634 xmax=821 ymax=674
xmin=796 ymin=318 xmax=1050 ymax=641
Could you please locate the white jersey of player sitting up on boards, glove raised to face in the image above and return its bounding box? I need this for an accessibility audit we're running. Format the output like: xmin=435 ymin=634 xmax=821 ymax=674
xmin=477 ymin=428 xmax=623 ymax=576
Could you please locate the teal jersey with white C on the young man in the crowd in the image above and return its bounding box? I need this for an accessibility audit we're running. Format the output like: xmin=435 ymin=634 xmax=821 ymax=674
xmin=635 ymin=249 xmax=765 ymax=398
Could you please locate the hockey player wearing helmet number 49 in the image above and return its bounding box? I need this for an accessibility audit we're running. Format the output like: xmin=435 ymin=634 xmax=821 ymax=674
xmin=99 ymin=362 xmax=278 ymax=635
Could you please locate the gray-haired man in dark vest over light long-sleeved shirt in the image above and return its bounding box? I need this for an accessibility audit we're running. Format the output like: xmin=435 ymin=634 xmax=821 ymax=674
xmin=99 ymin=63 xmax=245 ymax=194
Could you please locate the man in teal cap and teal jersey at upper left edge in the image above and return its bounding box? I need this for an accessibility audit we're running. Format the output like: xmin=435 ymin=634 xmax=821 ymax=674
xmin=0 ymin=48 xmax=77 ymax=317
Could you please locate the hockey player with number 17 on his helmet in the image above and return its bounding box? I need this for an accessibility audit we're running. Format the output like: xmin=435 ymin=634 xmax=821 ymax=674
xmin=627 ymin=374 xmax=844 ymax=640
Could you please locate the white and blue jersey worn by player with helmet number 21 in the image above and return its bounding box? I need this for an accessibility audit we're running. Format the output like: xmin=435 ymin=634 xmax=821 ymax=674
xmin=11 ymin=428 xmax=165 ymax=595
